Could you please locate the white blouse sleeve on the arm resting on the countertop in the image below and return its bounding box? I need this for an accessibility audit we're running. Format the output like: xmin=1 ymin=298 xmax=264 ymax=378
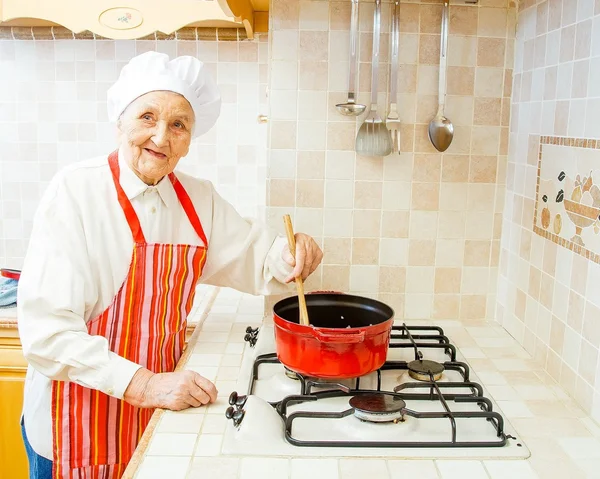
xmin=17 ymin=175 xmax=140 ymax=398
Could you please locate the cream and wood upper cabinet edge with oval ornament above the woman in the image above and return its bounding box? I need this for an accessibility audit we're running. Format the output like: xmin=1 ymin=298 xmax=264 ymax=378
xmin=0 ymin=0 xmax=269 ymax=40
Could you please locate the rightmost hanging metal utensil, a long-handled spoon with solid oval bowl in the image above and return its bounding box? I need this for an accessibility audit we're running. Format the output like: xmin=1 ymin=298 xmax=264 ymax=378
xmin=429 ymin=0 xmax=454 ymax=151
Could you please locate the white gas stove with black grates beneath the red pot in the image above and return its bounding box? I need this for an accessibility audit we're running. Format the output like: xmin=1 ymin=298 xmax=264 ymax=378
xmin=222 ymin=323 xmax=530 ymax=459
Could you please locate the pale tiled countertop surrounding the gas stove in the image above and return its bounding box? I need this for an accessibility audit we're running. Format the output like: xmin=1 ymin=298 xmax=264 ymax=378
xmin=123 ymin=290 xmax=600 ymax=479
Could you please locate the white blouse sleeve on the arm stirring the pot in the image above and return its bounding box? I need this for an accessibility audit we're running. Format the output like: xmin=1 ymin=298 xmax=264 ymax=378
xmin=201 ymin=185 xmax=293 ymax=295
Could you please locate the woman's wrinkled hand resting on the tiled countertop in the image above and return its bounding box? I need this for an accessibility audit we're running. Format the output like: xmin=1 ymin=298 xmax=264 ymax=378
xmin=123 ymin=368 xmax=217 ymax=411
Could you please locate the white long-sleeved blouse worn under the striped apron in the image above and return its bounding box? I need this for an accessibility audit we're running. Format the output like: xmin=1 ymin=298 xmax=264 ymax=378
xmin=17 ymin=147 xmax=292 ymax=459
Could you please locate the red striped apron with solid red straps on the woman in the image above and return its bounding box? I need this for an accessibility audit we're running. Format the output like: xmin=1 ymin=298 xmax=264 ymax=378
xmin=52 ymin=152 xmax=208 ymax=479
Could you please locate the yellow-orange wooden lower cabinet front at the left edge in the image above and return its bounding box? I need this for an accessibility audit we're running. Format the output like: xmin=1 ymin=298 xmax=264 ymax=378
xmin=0 ymin=330 xmax=28 ymax=479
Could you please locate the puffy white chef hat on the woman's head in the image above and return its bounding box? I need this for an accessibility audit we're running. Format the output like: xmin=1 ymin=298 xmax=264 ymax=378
xmin=107 ymin=51 xmax=221 ymax=137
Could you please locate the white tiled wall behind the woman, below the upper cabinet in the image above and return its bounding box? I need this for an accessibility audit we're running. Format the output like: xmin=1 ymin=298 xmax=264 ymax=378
xmin=0 ymin=36 xmax=268 ymax=268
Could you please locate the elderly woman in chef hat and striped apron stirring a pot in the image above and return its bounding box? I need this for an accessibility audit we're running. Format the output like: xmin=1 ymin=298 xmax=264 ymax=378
xmin=18 ymin=52 xmax=322 ymax=479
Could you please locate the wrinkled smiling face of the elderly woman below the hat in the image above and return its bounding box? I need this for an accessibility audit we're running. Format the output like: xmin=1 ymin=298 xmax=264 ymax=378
xmin=117 ymin=91 xmax=194 ymax=185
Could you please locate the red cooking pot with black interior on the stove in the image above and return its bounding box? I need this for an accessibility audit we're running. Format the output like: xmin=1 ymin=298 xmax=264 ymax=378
xmin=273 ymin=293 xmax=394 ymax=379
